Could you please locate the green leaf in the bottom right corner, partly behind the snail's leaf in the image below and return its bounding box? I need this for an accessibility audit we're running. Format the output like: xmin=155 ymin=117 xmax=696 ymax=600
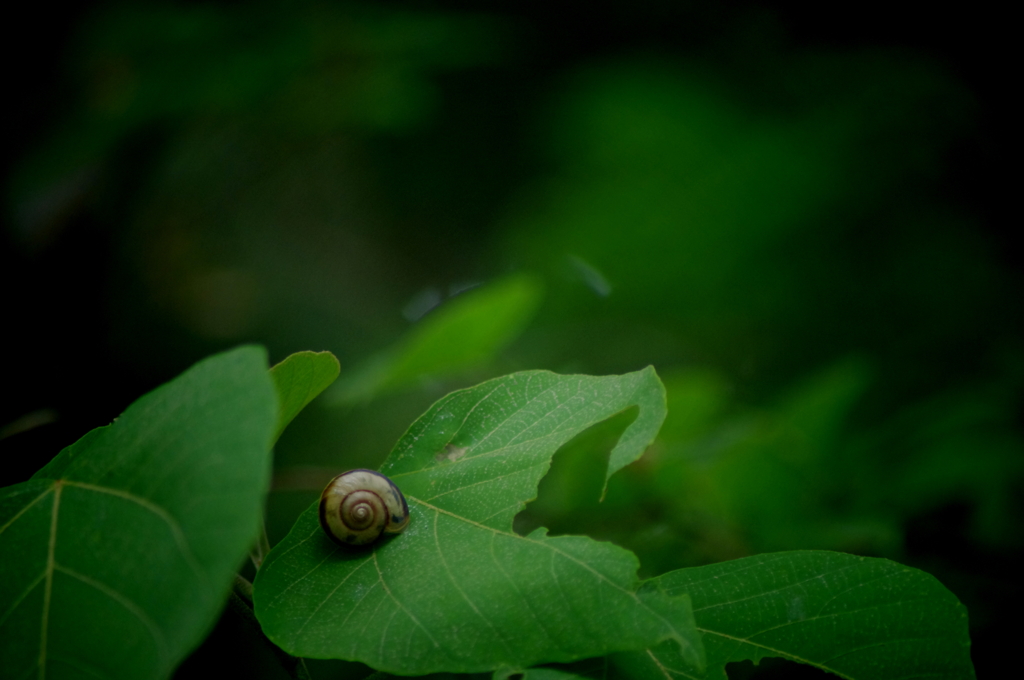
xmin=612 ymin=551 xmax=974 ymax=680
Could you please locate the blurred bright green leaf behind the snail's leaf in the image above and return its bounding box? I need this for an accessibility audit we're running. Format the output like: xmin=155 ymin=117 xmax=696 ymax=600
xmin=331 ymin=274 xmax=543 ymax=405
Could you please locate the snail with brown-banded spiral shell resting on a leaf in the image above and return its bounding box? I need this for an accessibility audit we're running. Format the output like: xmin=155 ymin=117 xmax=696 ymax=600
xmin=319 ymin=470 xmax=409 ymax=546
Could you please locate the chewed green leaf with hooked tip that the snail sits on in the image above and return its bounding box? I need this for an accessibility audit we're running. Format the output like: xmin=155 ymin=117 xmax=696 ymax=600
xmin=254 ymin=368 xmax=702 ymax=675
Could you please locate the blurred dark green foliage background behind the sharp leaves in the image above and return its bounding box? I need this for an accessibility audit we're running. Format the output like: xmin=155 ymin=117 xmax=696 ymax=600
xmin=0 ymin=0 xmax=1024 ymax=678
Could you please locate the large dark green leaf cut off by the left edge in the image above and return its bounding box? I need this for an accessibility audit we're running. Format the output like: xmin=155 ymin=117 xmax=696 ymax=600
xmin=0 ymin=347 xmax=278 ymax=680
